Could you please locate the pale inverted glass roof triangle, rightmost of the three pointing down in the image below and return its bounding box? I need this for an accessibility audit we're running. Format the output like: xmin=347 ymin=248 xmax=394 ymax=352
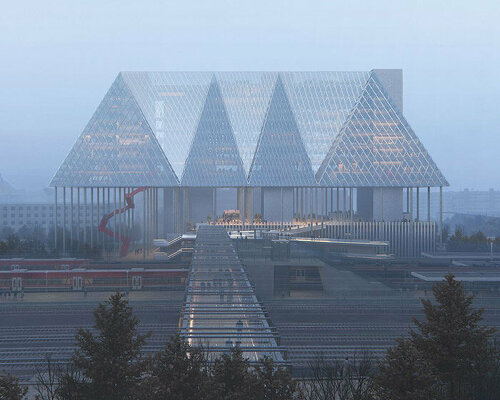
xmin=280 ymin=72 xmax=370 ymax=173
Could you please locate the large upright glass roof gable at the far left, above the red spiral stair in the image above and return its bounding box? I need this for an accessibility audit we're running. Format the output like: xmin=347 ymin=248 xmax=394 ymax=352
xmin=51 ymin=74 xmax=178 ymax=187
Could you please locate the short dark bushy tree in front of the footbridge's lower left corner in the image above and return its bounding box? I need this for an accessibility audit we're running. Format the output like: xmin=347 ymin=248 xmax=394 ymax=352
xmin=143 ymin=336 xmax=210 ymax=400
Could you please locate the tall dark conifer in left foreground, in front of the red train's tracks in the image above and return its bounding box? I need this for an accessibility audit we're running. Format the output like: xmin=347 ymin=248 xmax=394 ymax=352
xmin=61 ymin=293 xmax=147 ymax=400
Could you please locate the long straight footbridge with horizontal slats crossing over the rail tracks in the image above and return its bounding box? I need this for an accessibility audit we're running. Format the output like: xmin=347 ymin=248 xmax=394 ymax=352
xmin=181 ymin=226 xmax=284 ymax=363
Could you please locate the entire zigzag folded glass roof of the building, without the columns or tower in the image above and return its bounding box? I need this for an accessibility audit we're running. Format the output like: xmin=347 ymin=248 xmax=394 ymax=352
xmin=51 ymin=71 xmax=448 ymax=187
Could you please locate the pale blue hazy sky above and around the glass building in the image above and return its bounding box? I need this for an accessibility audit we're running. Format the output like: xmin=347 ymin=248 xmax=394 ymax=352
xmin=0 ymin=0 xmax=500 ymax=189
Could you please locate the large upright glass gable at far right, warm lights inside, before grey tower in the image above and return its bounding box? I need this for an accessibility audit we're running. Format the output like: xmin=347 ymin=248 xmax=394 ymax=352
xmin=316 ymin=74 xmax=448 ymax=187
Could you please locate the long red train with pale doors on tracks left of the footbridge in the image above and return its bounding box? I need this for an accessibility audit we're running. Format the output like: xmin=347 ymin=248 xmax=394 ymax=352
xmin=0 ymin=268 xmax=188 ymax=293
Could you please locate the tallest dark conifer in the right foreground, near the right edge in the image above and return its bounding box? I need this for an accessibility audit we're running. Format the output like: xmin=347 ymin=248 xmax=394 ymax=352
xmin=410 ymin=273 xmax=496 ymax=399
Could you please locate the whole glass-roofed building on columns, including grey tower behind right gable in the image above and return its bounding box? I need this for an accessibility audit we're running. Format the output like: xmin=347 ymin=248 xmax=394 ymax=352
xmin=51 ymin=70 xmax=448 ymax=253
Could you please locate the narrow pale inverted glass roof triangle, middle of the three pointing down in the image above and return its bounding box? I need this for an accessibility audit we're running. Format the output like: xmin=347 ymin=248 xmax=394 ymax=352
xmin=216 ymin=72 xmax=278 ymax=175
